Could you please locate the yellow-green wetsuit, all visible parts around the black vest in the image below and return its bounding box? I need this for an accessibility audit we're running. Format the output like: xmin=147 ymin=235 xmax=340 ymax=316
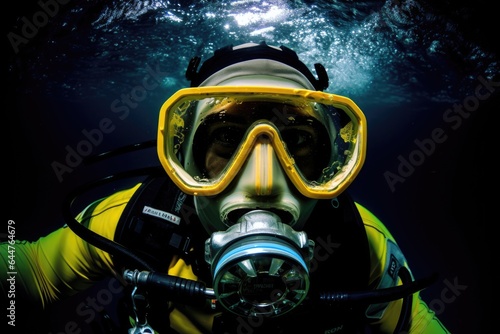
xmin=0 ymin=185 xmax=449 ymax=334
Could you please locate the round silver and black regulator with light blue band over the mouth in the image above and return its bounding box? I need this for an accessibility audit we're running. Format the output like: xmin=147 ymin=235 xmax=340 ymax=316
xmin=205 ymin=210 xmax=314 ymax=317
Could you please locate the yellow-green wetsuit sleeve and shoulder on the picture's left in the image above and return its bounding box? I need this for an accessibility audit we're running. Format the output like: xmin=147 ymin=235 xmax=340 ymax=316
xmin=0 ymin=186 xmax=138 ymax=307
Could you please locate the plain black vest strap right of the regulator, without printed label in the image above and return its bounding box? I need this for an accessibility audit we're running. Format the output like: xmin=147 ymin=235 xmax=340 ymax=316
xmin=300 ymin=192 xmax=370 ymax=333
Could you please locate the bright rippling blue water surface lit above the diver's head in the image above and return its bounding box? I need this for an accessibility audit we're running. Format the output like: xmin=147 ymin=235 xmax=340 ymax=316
xmin=9 ymin=1 xmax=498 ymax=105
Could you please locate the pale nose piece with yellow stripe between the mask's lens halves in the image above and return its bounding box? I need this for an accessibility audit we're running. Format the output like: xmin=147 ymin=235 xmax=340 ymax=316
xmin=238 ymin=136 xmax=287 ymax=196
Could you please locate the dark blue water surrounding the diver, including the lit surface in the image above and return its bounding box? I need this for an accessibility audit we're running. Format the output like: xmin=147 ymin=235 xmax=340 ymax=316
xmin=4 ymin=0 xmax=500 ymax=333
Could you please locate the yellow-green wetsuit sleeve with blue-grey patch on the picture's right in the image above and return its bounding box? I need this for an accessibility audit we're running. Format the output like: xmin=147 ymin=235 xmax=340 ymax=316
xmin=356 ymin=204 xmax=449 ymax=334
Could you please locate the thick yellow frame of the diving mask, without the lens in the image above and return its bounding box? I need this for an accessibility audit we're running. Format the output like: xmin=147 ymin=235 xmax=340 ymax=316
xmin=157 ymin=86 xmax=367 ymax=199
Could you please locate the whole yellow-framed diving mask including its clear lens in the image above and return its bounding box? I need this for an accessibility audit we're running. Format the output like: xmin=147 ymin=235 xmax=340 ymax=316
xmin=158 ymin=86 xmax=366 ymax=199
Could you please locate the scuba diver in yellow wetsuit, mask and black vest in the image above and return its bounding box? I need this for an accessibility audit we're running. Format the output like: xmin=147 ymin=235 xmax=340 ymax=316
xmin=0 ymin=42 xmax=448 ymax=334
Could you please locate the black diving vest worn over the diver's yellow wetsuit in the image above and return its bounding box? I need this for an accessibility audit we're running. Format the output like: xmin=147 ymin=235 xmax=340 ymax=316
xmin=115 ymin=176 xmax=370 ymax=334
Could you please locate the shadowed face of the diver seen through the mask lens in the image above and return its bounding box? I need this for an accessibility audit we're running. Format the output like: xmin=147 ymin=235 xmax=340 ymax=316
xmin=198 ymin=102 xmax=329 ymax=180
